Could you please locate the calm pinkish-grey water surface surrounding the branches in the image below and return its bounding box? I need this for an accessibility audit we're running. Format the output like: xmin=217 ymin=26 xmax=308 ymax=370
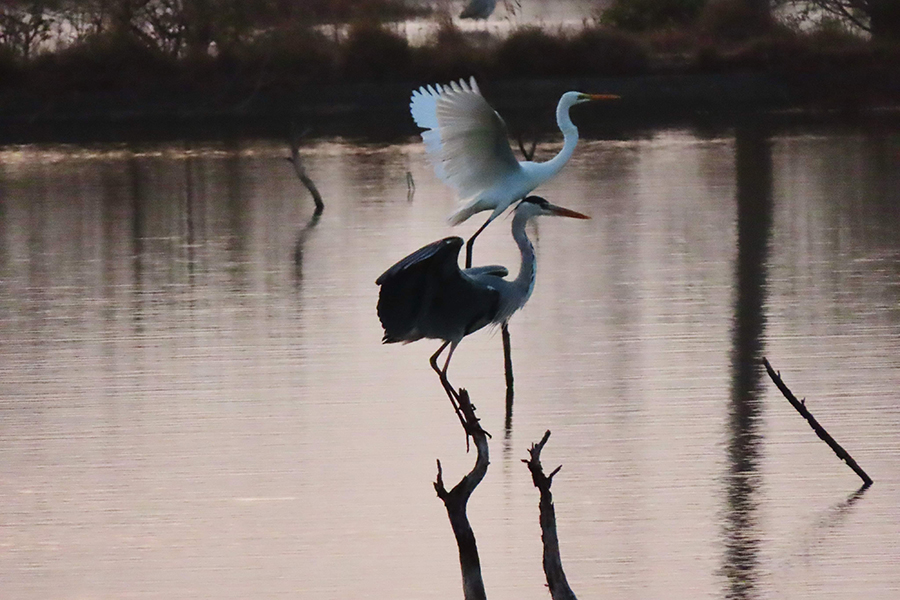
xmin=0 ymin=123 xmax=900 ymax=600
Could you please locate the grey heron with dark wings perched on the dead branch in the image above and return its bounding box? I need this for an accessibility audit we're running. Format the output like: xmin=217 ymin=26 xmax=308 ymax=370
xmin=375 ymin=196 xmax=590 ymax=425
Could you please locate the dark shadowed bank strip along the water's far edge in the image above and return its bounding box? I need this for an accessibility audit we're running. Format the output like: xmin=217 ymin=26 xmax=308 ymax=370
xmin=0 ymin=69 xmax=900 ymax=144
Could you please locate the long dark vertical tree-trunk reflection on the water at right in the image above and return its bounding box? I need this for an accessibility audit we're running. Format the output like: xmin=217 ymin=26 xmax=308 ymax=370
xmin=721 ymin=125 xmax=773 ymax=599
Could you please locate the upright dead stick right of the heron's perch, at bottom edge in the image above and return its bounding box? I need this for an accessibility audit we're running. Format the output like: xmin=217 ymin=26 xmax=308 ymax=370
xmin=522 ymin=429 xmax=577 ymax=600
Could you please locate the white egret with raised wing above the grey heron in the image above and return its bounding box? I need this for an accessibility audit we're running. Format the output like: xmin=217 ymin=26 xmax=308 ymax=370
xmin=409 ymin=77 xmax=618 ymax=266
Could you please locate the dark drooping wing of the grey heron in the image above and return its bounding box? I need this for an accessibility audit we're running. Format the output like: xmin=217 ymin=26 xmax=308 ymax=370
xmin=375 ymin=237 xmax=500 ymax=343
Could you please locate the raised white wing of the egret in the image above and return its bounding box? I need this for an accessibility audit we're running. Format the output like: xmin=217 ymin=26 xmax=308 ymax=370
xmin=409 ymin=77 xmax=519 ymax=200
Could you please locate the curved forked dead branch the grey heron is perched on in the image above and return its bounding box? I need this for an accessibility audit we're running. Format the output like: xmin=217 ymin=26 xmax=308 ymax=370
xmin=434 ymin=389 xmax=490 ymax=600
